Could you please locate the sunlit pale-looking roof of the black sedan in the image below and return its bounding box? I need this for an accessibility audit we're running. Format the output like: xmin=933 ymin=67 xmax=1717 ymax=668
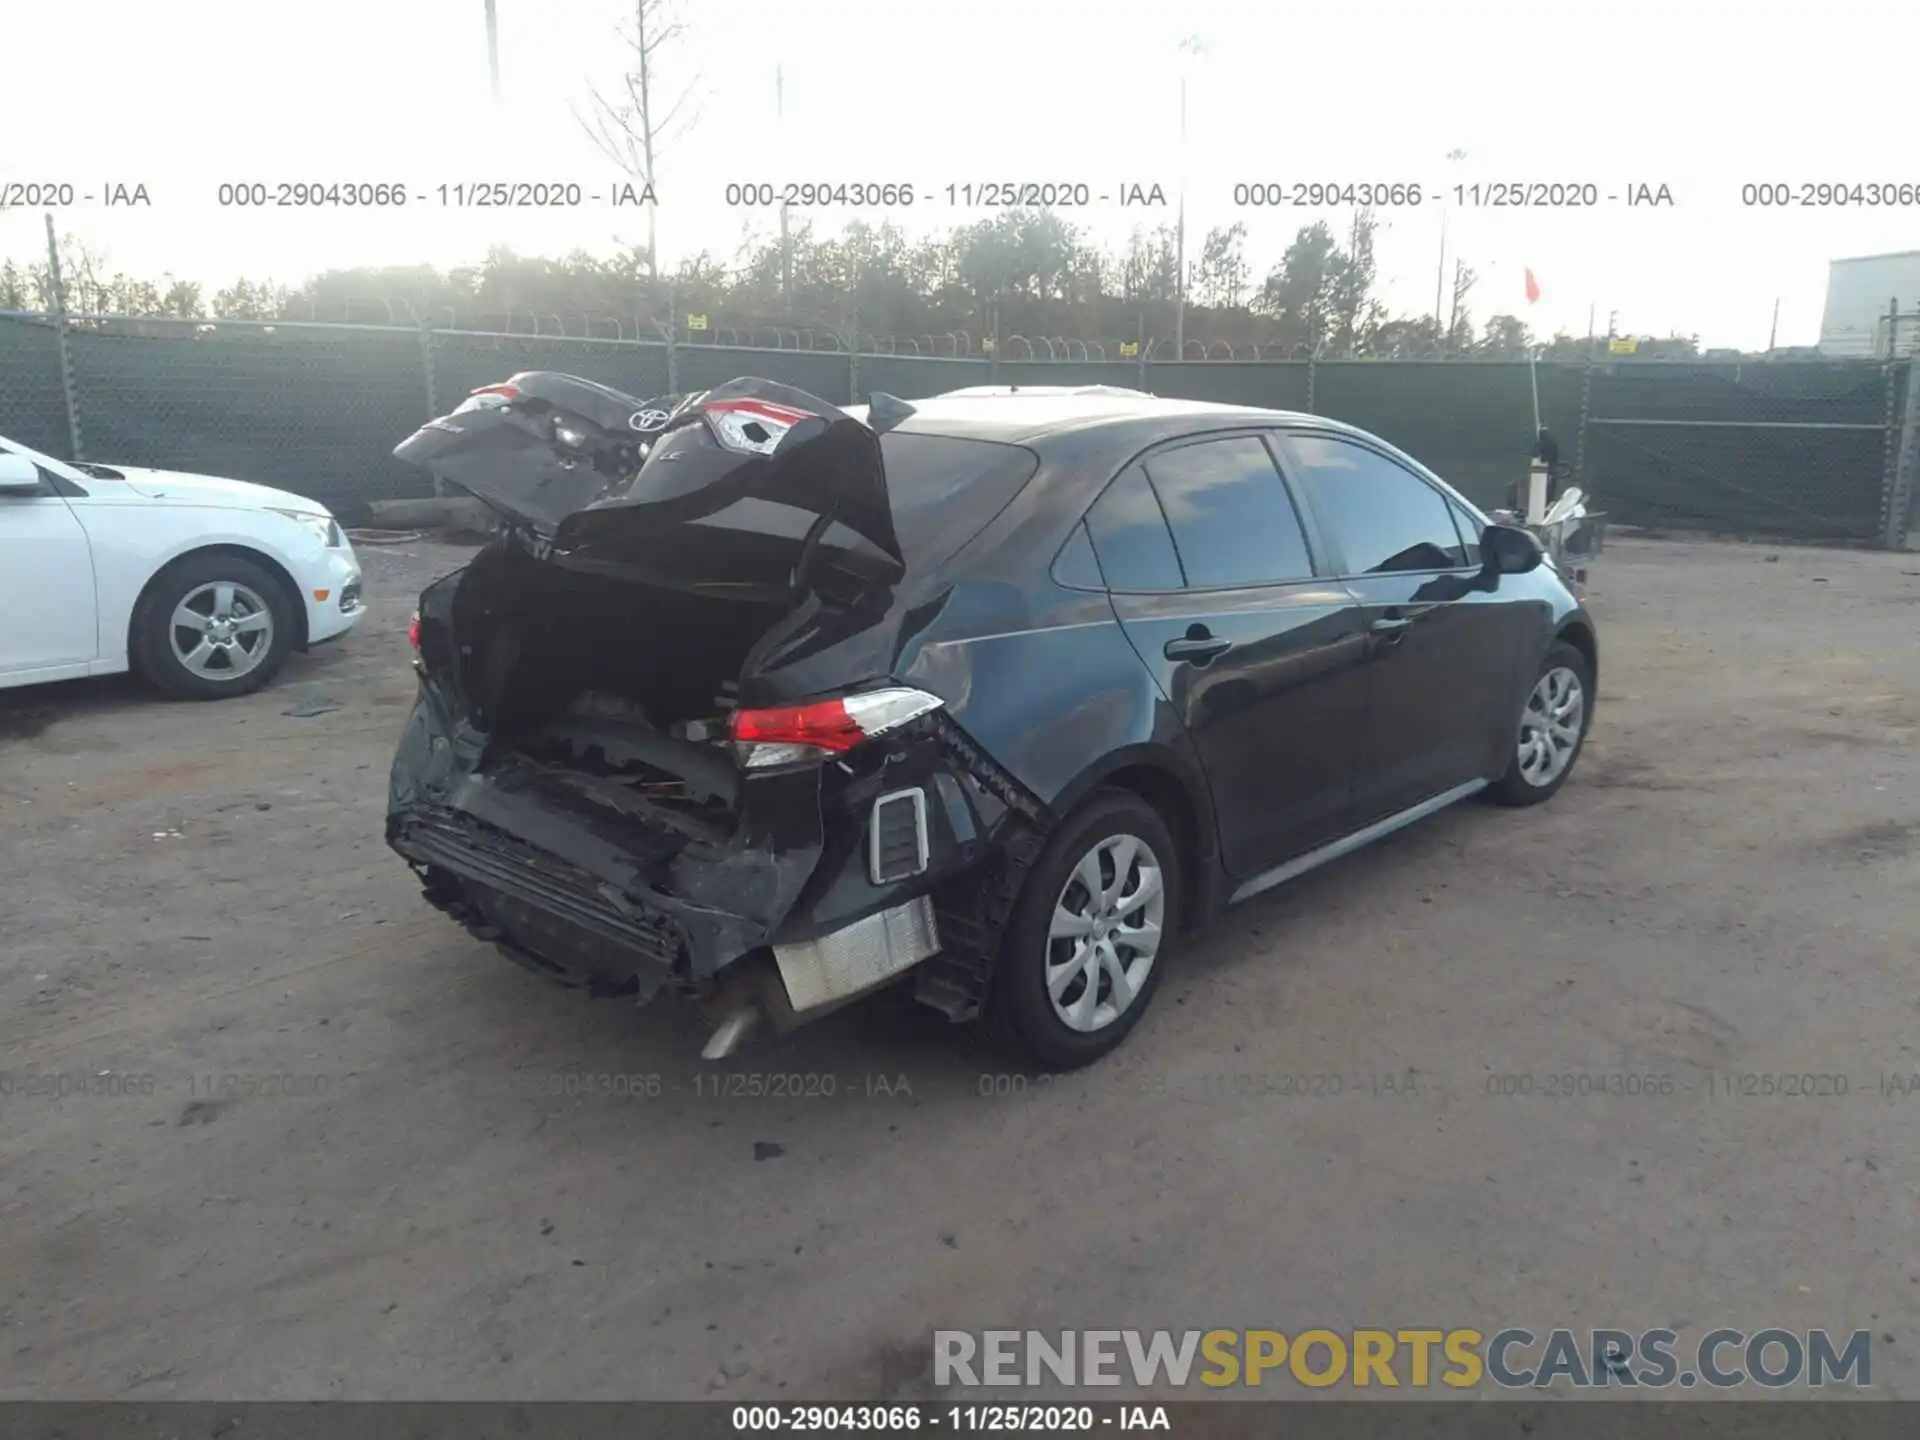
xmin=847 ymin=386 xmax=1350 ymax=445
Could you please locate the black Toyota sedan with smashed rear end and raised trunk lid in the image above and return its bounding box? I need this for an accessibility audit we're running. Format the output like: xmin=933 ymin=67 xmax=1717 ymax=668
xmin=388 ymin=372 xmax=1597 ymax=1068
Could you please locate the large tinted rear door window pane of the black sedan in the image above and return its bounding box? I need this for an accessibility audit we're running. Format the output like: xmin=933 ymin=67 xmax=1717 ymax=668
xmin=1146 ymin=436 xmax=1313 ymax=589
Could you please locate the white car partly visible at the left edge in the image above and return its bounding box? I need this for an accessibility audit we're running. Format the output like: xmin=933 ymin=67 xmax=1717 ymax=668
xmin=0 ymin=436 xmax=365 ymax=701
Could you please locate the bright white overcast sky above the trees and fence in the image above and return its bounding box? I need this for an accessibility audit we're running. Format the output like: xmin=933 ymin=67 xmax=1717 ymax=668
xmin=0 ymin=0 xmax=1920 ymax=348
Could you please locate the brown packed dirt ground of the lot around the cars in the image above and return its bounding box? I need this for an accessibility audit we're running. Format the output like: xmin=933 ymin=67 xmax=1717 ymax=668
xmin=0 ymin=541 xmax=1920 ymax=1400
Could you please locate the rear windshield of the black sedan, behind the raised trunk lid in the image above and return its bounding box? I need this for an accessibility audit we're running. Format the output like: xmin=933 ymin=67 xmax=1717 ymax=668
xmin=879 ymin=430 xmax=1041 ymax=570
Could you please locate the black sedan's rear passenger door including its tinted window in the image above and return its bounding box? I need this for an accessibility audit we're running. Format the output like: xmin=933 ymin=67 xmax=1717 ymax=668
xmin=1087 ymin=432 xmax=1367 ymax=877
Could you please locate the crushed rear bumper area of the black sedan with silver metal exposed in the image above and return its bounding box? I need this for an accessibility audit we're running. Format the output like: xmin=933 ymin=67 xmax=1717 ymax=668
xmin=386 ymin=680 xmax=1025 ymax=1029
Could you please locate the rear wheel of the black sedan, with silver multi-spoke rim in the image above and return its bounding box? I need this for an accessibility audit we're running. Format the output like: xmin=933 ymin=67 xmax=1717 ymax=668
xmin=995 ymin=791 xmax=1183 ymax=1071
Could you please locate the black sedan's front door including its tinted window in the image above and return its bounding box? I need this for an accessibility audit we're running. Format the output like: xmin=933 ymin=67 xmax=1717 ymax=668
xmin=1283 ymin=430 xmax=1524 ymax=828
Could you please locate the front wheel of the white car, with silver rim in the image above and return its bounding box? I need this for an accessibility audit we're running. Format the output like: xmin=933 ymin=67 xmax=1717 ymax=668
xmin=132 ymin=553 xmax=296 ymax=701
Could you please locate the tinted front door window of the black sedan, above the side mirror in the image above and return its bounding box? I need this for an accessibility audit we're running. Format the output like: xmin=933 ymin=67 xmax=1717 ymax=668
xmin=1286 ymin=434 xmax=1467 ymax=574
